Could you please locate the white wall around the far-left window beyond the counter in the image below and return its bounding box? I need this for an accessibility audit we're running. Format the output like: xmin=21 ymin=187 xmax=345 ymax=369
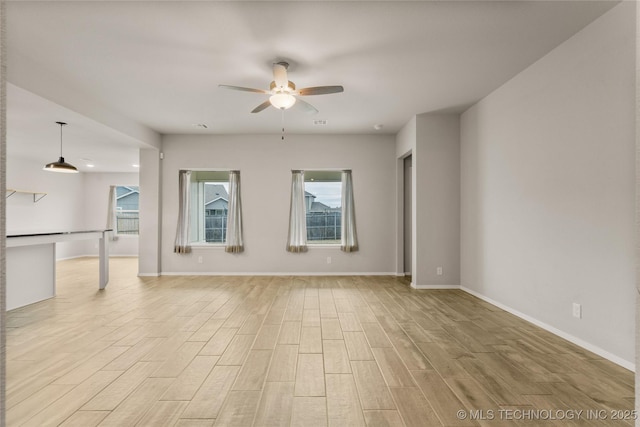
xmin=84 ymin=173 xmax=139 ymax=256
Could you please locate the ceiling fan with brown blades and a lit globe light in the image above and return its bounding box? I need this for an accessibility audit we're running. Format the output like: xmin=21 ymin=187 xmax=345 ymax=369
xmin=219 ymin=61 xmax=344 ymax=114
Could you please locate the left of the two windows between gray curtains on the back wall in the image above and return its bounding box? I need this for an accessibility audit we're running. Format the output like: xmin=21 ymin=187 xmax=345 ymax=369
xmin=191 ymin=171 xmax=229 ymax=243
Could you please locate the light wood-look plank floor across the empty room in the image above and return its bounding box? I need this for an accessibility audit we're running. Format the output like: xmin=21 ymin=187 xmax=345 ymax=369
xmin=7 ymin=258 xmax=634 ymax=427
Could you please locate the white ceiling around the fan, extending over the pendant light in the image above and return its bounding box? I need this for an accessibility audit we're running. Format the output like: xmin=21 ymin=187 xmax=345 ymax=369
xmin=7 ymin=1 xmax=615 ymax=171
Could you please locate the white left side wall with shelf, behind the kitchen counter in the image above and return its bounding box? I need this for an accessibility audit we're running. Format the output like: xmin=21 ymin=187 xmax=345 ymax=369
xmin=6 ymin=157 xmax=85 ymax=259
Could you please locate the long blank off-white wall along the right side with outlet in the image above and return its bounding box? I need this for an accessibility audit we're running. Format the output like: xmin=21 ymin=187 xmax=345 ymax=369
xmin=461 ymin=2 xmax=635 ymax=367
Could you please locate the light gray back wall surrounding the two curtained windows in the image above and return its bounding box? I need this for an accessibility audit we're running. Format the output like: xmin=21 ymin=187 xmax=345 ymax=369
xmin=162 ymin=135 xmax=396 ymax=274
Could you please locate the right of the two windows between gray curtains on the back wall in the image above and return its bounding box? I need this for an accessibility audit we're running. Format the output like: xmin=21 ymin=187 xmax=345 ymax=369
xmin=304 ymin=171 xmax=342 ymax=245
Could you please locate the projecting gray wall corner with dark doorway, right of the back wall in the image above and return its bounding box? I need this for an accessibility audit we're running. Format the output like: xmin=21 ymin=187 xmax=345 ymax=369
xmin=396 ymin=114 xmax=460 ymax=288
